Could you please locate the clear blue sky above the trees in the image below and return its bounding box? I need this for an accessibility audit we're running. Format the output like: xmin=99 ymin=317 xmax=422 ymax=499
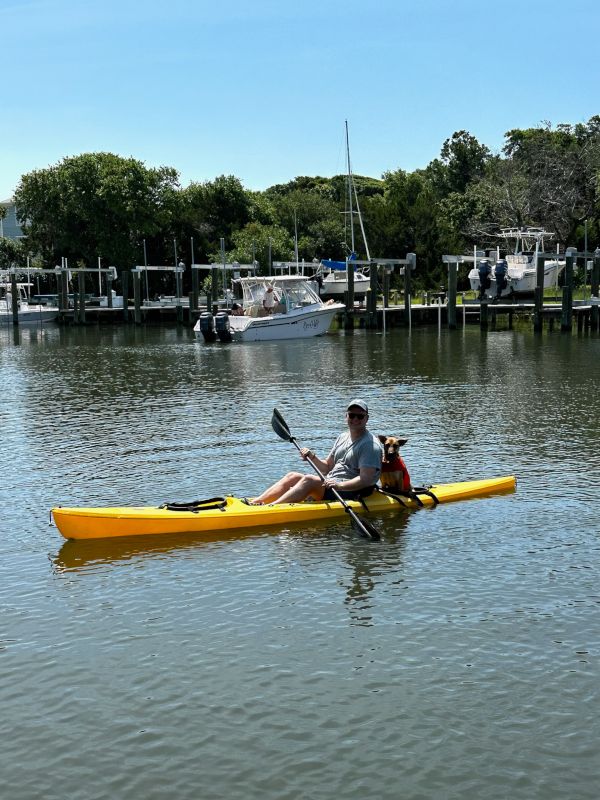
xmin=0 ymin=0 xmax=600 ymax=199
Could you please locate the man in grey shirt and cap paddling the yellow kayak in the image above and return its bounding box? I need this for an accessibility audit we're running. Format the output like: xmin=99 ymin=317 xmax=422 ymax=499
xmin=252 ymin=398 xmax=383 ymax=505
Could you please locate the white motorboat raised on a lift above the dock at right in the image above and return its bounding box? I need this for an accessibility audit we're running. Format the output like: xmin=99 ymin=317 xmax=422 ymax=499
xmin=468 ymin=227 xmax=566 ymax=298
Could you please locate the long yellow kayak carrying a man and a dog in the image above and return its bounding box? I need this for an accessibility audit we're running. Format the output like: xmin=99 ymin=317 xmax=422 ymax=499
xmin=51 ymin=475 xmax=516 ymax=539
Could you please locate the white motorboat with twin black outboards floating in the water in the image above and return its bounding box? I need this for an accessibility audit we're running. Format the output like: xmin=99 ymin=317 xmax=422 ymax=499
xmin=194 ymin=275 xmax=345 ymax=342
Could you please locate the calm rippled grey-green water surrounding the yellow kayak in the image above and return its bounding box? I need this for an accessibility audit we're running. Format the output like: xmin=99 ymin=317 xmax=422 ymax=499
xmin=0 ymin=328 xmax=600 ymax=800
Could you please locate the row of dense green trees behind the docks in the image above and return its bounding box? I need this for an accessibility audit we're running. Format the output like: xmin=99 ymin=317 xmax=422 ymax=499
xmin=0 ymin=116 xmax=600 ymax=288
